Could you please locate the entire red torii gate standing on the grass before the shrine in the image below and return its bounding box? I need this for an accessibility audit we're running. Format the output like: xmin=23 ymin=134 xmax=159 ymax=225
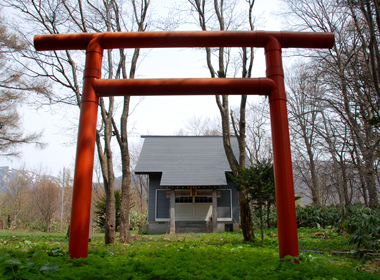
xmin=34 ymin=31 xmax=334 ymax=258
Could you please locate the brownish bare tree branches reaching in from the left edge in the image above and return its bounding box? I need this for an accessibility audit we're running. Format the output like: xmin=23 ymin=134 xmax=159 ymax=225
xmin=0 ymin=14 xmax=47 ymax=157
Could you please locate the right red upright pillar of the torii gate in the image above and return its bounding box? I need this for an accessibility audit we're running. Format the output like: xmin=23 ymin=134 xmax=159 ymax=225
xmin=264 ymin=38 xmax=299 ymax=259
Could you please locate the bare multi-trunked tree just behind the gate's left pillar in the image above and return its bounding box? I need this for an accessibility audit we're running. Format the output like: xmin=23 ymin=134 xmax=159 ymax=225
xmin=4 ymin=0 xmax=150 ymax=243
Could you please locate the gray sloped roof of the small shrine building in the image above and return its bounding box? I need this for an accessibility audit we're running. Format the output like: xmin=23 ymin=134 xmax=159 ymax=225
xmin=135 ymin=136 xmax=238 ymax=186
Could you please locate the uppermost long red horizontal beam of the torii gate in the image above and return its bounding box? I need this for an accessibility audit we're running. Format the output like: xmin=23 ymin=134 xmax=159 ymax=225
xmin=34 ymin=31 xmax=334 ymax=51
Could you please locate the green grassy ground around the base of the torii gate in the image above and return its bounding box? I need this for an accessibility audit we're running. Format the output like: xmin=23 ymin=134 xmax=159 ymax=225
xmin=0 ymin=229 xmax=380 ymax=280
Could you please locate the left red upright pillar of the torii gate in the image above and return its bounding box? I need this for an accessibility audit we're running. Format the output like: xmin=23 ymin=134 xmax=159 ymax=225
xmin=68 ymin=38 xmax=103 ymax=259
